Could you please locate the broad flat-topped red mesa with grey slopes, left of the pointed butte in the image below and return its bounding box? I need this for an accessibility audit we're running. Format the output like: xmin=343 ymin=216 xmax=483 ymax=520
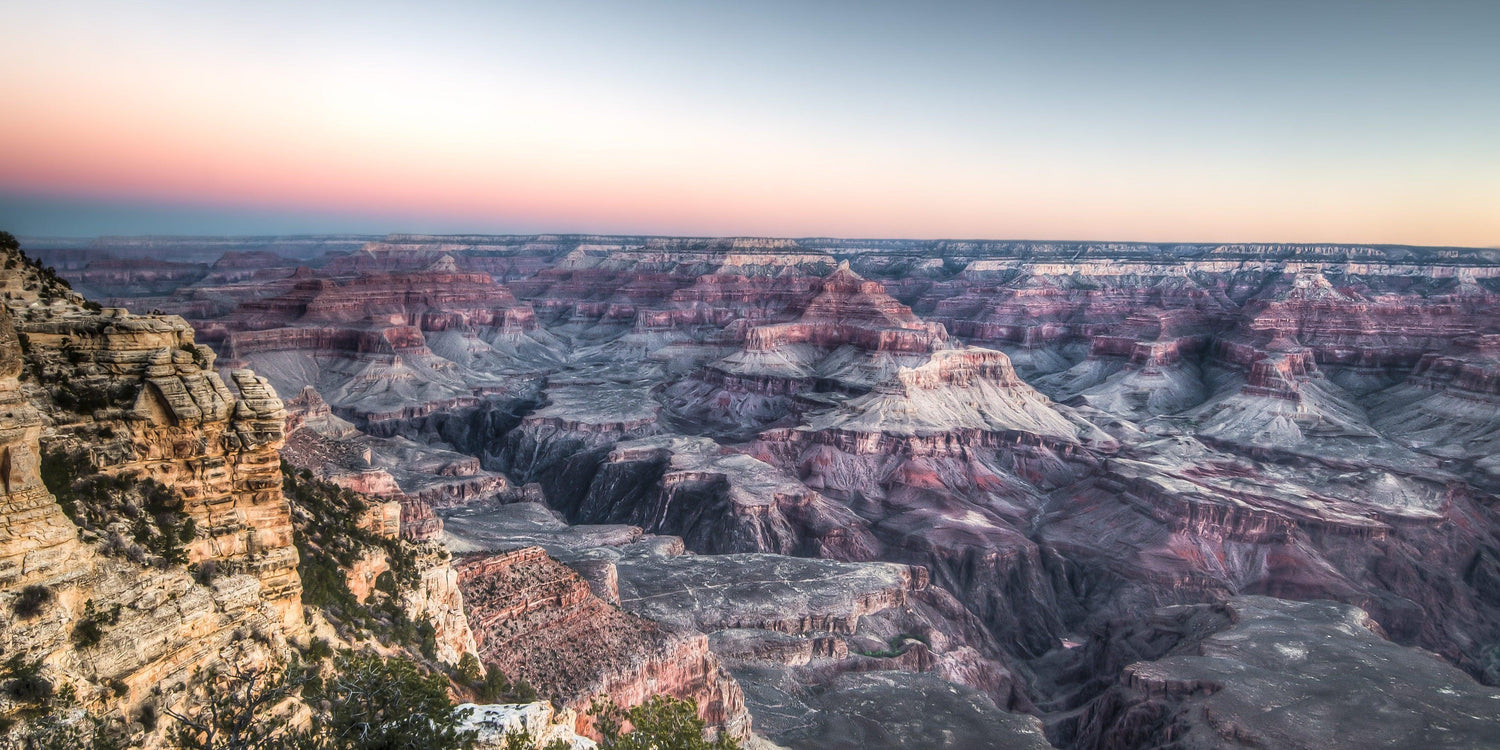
xmin=222 ymin=255 xmax=549 ymax=435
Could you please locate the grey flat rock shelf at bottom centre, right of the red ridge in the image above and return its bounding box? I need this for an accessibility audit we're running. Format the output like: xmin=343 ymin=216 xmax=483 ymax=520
xmin=447 ymin=504 xmax=1040 ymax=747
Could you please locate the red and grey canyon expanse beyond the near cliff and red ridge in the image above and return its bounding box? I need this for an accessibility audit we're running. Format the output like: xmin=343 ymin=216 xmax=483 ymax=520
xmin=55 ymin=236 xmax=1500 ymax=747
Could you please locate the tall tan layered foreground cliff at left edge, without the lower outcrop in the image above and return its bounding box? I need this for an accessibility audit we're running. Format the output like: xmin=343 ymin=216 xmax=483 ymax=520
xmin=0 ymin=253 xmax=305 ymax=747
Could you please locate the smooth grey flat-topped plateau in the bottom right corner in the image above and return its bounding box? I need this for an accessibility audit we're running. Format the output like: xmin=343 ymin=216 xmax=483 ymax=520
xmin=1070 ymin=597 xmax=1500 ymax=749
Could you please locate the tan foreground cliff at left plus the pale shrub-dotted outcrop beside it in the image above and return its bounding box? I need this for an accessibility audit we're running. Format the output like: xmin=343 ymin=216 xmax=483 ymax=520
xmin=0 ymin=243 xmax=476 ymax=747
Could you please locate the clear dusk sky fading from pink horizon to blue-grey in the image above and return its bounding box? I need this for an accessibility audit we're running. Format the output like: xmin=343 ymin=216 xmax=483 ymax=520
xmin=0 ymin=0 xmax=1500 ymax=246
